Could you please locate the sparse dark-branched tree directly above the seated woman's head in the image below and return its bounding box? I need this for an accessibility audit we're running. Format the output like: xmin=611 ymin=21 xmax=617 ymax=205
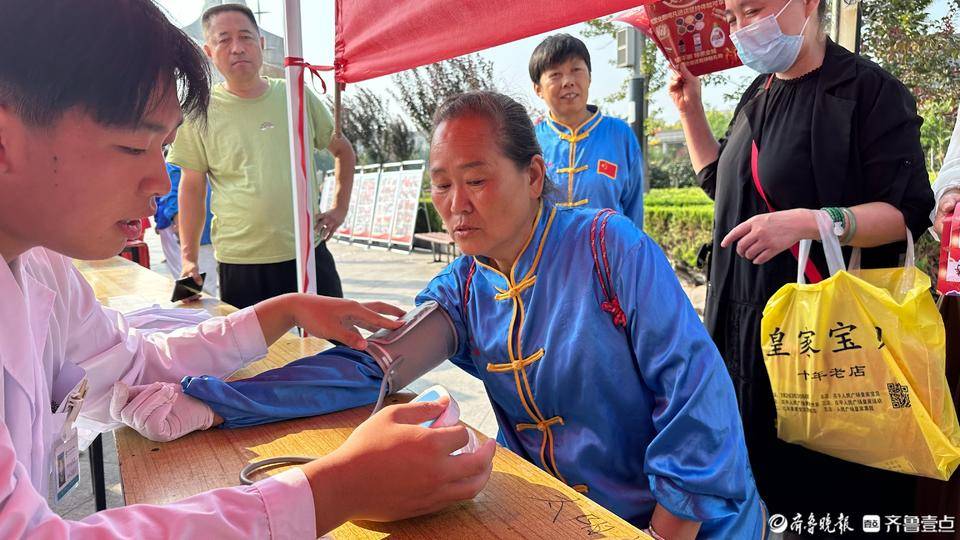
xmin=390 ymin=54 xmax=496 ymax=137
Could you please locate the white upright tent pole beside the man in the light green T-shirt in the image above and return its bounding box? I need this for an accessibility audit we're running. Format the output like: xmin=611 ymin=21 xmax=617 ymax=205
xmin=283 ymin=0 xmax=317 ymax=294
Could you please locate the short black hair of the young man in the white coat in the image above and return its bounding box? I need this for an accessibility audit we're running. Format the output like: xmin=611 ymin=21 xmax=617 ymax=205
xmin=0 ymin=0 xmax=210 ymax=127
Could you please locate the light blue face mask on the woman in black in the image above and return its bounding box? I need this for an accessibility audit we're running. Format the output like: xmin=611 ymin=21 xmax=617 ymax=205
xmin=730 ymin=0 xmax=810 ymax=73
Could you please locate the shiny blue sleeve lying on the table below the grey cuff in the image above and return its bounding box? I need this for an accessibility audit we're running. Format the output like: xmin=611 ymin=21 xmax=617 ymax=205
xmin=180 ymin=347 xmax=383 ymax=428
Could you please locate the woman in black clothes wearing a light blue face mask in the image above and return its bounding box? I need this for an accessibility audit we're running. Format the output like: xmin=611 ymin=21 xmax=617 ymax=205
xmin=670 ymin=0 xmax=933 ymax=527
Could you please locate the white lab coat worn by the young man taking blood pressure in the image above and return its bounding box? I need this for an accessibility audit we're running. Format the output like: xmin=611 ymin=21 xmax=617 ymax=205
xmin=0 ymin=248 xmax=316 ymax=539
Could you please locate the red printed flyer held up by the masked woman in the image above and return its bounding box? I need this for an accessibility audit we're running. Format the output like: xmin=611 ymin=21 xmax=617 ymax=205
xmin=614 ymin=0 xmax=741 ymax=75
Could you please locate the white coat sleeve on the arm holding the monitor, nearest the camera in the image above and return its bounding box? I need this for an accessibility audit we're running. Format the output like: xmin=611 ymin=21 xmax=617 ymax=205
xmin=0 ymin=420 xmax=317 ymax=539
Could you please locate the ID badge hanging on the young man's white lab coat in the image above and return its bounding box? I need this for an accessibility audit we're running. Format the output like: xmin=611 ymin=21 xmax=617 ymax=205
xmin=50 ymin=378 xmax=87 ymax=502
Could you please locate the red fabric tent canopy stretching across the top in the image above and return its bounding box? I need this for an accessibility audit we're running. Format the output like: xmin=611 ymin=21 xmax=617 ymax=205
xmin=335 ymin=0 xmax=653 ymax=83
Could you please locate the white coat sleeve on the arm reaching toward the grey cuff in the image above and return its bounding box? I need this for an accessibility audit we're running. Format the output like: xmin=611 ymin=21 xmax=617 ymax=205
xmin=60 ymin=262 xmax=267 ymax=431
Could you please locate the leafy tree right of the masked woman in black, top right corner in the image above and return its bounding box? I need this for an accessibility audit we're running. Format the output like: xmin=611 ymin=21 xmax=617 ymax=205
xmin=860 ymin=0 xmax=960 ymax=170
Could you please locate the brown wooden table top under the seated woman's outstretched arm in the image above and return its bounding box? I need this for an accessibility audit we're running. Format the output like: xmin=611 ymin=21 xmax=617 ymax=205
xmin=76 ymin=257 xmax=649 ymax=540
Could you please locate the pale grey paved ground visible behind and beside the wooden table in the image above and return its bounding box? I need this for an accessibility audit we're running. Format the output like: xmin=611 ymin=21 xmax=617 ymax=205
xmin=53 ymin=230 xmax=705 ymax=519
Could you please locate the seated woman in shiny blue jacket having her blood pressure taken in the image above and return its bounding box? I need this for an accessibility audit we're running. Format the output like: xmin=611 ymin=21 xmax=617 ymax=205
xmin=114 ymin=92 xmax=766 ymax=539
